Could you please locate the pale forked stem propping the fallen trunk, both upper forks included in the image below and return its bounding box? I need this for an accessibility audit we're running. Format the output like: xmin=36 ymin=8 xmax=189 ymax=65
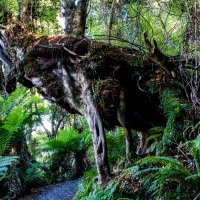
xmin=58 ymin=65 xmax=110 ymax=184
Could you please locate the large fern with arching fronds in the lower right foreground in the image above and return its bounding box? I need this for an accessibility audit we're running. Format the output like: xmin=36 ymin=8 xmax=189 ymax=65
xmin=133 ymin=156 xmax=199 ymax=197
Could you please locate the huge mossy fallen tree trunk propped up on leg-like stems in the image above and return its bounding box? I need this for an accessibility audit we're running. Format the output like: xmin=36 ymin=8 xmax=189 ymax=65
xmin=0 ymin=25 xmax=178 ymax=183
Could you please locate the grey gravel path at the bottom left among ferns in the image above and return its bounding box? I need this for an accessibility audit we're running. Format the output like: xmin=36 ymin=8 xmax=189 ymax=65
xmin=20 ymin=180 xmax=80 ymax=200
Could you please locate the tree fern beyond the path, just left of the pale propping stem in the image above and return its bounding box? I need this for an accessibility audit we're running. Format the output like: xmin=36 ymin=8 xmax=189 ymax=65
xmin=42 ymin=128 xmax=92 ymax=178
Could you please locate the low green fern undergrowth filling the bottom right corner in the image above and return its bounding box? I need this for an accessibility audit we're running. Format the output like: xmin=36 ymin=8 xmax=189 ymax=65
xmin=122 ymin=136 xmax=200 ymax=200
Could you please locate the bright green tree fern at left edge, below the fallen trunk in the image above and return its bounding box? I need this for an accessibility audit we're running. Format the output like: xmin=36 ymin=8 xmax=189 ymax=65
xmin=0 ymin=88 xmax=42 ymax=154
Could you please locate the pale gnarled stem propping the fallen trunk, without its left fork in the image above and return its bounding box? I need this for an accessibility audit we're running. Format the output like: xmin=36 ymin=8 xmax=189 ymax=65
xmin=80 ymin=77 xmax=110 ymax=184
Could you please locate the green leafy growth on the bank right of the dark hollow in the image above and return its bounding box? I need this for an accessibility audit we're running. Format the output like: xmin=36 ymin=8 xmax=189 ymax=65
xmin=161 ymin=90 xmax=192 ymax=149
